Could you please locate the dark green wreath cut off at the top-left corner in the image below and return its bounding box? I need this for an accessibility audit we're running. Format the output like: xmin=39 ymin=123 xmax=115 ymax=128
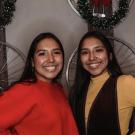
xmin=0 ymin=0 xmax=16 ymax=28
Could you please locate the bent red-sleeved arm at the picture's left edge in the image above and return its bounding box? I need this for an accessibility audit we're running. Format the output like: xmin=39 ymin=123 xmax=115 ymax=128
xmin=0 ymin=84 xmax=35 ymax=131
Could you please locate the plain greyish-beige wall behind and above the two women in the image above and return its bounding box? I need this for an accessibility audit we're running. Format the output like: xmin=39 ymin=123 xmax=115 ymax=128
xmin=6 ymin=0 xmax=135 ymax=84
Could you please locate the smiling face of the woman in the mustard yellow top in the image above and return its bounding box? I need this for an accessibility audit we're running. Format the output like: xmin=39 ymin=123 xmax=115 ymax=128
xmin=80 ymin=37 xmax=109 ymax=77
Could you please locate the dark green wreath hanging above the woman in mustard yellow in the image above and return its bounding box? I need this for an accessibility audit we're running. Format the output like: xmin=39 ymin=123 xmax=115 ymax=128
xmin=77 ymin=0 xmax=129 ymax=29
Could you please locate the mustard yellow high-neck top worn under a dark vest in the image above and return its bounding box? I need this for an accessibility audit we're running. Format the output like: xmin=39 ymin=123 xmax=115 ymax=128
xmin=85 ymin=72 xmax=135 ymax=135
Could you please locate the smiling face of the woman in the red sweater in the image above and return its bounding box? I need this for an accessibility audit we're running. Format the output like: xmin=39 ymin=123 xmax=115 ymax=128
xmin=33 ymin=38 xmax=63 ymax=82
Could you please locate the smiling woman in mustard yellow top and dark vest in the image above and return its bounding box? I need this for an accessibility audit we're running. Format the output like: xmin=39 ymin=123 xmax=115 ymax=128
xmin=70 ymin=32 xmax=135 ymax=135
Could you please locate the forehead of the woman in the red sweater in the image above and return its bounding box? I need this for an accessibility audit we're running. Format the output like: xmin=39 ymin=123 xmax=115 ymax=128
xmin=36 ymin=38 xmax=61 ymax=50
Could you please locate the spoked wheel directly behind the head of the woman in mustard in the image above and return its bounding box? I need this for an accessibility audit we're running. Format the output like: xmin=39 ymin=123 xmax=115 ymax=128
xmin=66 ymin=37 xmax=135 ymax=88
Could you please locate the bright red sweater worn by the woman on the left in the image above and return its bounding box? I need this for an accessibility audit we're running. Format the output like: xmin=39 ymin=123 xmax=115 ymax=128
xmin=0 ymin=81 xmax=78 ymax=135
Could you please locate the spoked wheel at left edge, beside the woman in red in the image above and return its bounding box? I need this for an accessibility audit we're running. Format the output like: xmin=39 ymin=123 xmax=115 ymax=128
xmin=0 ymin=41 xmax=25 ymax=90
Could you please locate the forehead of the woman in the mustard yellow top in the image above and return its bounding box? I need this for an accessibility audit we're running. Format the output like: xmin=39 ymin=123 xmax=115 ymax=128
xmin=81 ymin=37 xmax=105 ymax=48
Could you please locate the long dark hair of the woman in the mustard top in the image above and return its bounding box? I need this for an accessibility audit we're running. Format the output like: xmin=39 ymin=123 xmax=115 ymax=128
xmin=70 ymin=31 xmax=122 ymax=134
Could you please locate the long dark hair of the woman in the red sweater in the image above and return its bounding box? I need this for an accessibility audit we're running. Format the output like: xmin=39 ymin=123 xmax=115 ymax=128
xmin=19 ymin=32 xmax=64 ymax=82
